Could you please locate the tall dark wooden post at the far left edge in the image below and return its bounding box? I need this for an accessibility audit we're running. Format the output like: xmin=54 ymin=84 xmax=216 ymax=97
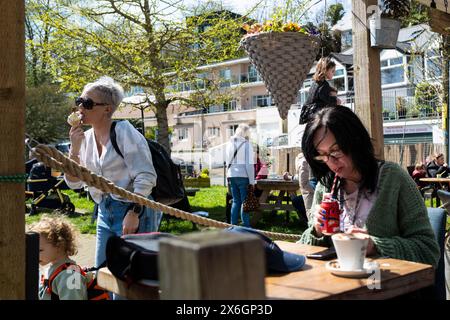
xmin=0 ymin=0 xmax=25 ymax=300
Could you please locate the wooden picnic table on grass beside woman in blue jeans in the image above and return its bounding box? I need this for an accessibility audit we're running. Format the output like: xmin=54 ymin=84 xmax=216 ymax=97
xmin=251 ymin=179 xmax=300 ymax=225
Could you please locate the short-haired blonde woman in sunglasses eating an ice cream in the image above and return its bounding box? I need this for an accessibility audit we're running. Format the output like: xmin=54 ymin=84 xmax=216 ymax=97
xmin=64 ymin=77 xmax=162 ymax=267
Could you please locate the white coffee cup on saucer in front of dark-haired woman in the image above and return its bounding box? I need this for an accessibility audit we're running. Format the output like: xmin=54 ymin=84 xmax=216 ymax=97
xmin=331 ymin=233 xmax=369 ymax=271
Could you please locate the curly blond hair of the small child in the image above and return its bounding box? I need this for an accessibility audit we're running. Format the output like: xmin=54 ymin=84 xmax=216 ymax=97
xmin=30 ymin=214 xmax=77 ymax=256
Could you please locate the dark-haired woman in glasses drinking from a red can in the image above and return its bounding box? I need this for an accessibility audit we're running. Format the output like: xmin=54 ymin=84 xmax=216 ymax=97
xmin=300 ymin=107 xmax=439 ymax=266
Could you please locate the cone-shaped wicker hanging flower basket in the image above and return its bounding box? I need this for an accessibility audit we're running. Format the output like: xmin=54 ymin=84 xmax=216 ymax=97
xmin=241 ymin=32 xmax=319 ymax=119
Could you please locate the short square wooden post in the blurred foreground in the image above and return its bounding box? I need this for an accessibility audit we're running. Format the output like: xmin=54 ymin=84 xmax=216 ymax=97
xmin=159 ymin=231 xmax=266 ymax=300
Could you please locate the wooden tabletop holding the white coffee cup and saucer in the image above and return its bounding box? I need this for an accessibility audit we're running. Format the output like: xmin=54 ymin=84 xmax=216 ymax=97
xmin=98 ymin=241 xmax=434 ymax=300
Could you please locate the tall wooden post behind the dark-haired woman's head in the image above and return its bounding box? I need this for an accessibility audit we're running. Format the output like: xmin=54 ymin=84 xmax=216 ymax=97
xmin=352 ymin=0 xmax=384 ymax=159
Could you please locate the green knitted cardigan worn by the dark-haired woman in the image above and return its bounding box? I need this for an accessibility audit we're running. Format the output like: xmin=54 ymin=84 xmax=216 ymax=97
xmin=299 ymin=162 xmax=439 ymax=267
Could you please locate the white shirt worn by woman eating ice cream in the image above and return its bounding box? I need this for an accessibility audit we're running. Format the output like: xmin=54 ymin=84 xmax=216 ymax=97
xmin=65 ymin=121 xmax=156 ymax=203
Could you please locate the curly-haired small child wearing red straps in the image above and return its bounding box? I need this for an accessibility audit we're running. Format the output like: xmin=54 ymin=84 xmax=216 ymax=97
xmin=30 ymin=215 xmax=89 ymax=300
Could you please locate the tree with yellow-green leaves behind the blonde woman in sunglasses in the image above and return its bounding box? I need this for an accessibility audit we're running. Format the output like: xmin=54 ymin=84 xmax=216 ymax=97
xmin=37 ymin=0 xmax=250 ymax=151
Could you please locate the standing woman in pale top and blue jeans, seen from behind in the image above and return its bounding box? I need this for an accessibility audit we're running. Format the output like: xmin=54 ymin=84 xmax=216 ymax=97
xmin=226 ymin=124 xmax=255 ymax=227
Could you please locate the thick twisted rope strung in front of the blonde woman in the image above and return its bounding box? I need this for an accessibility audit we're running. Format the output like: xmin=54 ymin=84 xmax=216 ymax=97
xmin=32 ymin=144 xmax=300 ymax=240
